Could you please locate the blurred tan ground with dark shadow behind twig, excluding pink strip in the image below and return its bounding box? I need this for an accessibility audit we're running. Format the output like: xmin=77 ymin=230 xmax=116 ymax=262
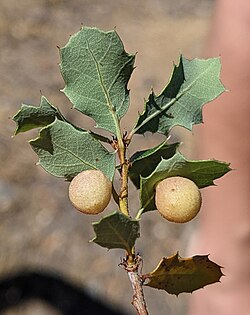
xmin=0 ymin=0 xmax=219 ymax=315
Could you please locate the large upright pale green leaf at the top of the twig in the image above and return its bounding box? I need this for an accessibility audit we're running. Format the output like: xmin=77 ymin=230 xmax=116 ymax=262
xmin=60 ymin=27 xmax=135 ymax=135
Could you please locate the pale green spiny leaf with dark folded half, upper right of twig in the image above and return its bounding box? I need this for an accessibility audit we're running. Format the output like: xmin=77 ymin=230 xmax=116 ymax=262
xmin=132 ymin=56 xmax=225 ymax=135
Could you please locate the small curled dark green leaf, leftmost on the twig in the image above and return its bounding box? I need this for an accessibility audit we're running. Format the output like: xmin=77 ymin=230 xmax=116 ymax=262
xmin=12 ymin=96 xmax=65 ymax=135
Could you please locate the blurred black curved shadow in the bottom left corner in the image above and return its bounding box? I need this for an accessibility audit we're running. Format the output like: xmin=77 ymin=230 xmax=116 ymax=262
xmin=0 ymin=271 xmax=128 ymax=315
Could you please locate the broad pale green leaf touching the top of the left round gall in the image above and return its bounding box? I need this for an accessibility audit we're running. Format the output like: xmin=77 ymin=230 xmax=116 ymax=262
xmin=30 ymin=119 xmax=115 ymax=180
